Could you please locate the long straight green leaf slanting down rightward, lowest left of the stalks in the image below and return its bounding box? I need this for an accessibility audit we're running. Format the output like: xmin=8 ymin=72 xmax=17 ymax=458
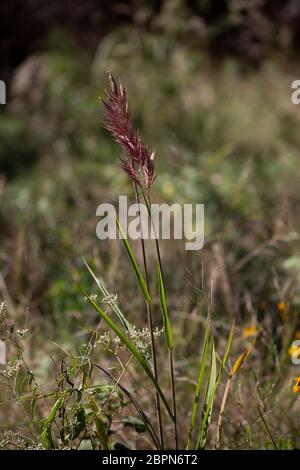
xmin=78 ymin=284 xmax=174 ymax=422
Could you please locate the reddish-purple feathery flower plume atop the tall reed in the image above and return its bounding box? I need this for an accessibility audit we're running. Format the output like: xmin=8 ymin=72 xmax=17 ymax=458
xmin=103 ymin=74 xmax=155 ymax=190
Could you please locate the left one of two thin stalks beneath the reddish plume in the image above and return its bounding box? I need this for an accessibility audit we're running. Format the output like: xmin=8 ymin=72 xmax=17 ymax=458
xmin=133 ymin=182 xmax=164 ymax=449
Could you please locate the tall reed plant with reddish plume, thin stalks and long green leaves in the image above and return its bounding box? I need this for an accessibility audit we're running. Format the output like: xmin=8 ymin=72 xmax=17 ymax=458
xmin=80 ymin=73 xmax=256 ymax=449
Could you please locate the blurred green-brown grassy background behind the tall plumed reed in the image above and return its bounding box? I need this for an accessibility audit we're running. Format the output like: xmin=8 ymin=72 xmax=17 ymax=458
xmin=0 ymin=2 xmax=300 ymax=448
